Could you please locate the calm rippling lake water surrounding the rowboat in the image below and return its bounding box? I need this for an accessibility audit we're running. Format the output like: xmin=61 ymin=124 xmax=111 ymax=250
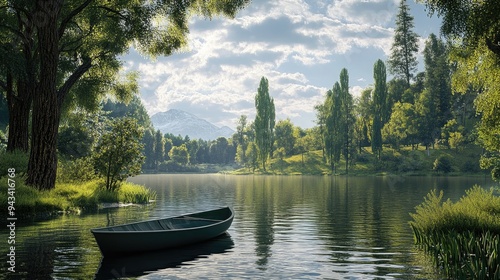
xmin=0 ymin=174 xmax=494 ymax=279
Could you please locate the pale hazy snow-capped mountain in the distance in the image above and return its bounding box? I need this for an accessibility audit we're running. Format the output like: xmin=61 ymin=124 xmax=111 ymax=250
xmin=151 ymin=109 xmax=234 ymax=140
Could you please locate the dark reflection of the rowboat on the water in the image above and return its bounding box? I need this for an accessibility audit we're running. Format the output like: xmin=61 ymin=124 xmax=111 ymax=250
xmin=95 ymin=233 xmax=234 ymax=280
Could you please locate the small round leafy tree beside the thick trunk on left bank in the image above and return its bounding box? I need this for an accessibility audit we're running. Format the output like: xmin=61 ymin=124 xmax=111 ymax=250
xmin=94 ymin=118 xmax=144 ymax=191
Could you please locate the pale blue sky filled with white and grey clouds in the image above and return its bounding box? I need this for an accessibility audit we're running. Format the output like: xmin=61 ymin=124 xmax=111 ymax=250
xmin=119 ymin=0 xmax=440 ymax=129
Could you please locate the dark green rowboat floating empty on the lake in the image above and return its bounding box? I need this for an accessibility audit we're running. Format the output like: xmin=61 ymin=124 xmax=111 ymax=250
xmin=91 ymin=207 xmax=234 ymax=256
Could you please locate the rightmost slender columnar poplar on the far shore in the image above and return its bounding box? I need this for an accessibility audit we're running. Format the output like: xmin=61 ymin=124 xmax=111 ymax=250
xmin=372 ymin=59 xmax=387 ymax=159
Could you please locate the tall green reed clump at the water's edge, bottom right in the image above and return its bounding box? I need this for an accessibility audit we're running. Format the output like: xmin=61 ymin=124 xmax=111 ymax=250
xmin=410 ymin=186 xmax=500 ymax=279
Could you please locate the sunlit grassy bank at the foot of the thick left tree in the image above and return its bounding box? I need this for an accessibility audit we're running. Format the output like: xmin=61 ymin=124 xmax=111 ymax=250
xmin=0 ymin=177 xmax=156 ymax=219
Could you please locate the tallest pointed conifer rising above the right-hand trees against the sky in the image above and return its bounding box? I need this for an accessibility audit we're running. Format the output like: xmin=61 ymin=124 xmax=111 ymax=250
xmin=388 ymin=0 xmax=418 ymax=87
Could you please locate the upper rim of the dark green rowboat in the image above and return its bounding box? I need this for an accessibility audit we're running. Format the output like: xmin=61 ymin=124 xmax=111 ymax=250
xmin=90 ymin=206 xmax=234 ymax=234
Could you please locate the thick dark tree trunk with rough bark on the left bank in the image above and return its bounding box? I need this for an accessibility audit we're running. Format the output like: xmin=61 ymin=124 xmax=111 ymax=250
xmin=26 ymin=0 xmax=61 ymax=190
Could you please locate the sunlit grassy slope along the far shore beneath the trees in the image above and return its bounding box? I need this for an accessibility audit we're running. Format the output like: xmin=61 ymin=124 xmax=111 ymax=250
xmin=231 ymin=145 xmax=487 ymax=175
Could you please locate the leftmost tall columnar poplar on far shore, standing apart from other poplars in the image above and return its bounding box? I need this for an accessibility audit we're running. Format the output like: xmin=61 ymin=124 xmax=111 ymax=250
xmin=254 ymin=77 xmax=275 ymax=171
